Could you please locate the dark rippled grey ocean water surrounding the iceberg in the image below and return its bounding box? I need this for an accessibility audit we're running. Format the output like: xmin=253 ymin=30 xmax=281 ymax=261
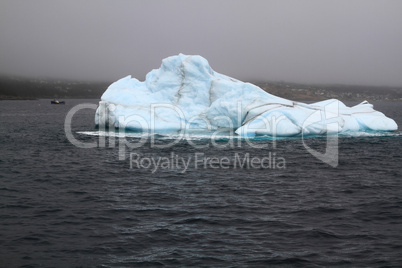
xmin=0 ymin=100 xmax=402 ymax=267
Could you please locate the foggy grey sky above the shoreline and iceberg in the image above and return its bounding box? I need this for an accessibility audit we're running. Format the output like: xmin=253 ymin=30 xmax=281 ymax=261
xmin=0 ymin=0 xmax=402 ymax=86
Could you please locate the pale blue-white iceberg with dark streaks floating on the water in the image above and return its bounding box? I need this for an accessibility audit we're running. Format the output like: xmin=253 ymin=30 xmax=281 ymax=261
xmin=95 ymin=54 xmax=398 ymax=137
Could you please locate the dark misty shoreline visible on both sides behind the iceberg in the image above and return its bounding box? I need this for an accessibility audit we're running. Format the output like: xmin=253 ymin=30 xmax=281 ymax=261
xmin=0 ymin=76 xmax=402 ymax=102
